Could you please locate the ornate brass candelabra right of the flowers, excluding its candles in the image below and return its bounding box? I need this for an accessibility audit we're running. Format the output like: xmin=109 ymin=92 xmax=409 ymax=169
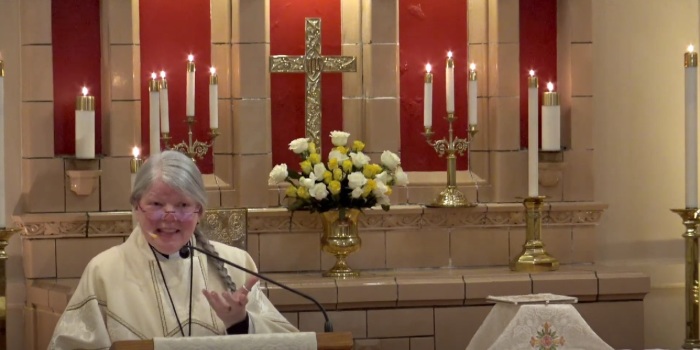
xmin=423 ymin=113 xmax=478 ymax=208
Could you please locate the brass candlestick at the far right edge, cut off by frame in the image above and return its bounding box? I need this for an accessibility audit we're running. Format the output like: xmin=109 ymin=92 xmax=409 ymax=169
xmin=671 ymin=208 xmax=700 ymax=349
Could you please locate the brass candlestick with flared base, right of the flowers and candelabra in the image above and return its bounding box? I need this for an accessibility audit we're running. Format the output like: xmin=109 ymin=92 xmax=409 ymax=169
xmin=510 ymin=196 xmax=559 ymax=272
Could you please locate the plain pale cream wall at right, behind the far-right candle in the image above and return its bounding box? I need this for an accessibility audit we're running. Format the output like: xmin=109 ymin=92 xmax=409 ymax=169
xmin=593 ymin=0 xmax=698 ymax=349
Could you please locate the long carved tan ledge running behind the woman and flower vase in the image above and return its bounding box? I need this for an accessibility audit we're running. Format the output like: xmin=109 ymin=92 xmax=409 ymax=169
xmin=13 ymin=202 xmax=607 ymax=238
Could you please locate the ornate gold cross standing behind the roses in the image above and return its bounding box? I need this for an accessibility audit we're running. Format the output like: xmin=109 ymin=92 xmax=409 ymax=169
xmin=270 ymin=18 xmax=357 ymax=152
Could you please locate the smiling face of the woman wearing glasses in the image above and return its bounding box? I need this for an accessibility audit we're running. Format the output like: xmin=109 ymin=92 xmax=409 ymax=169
xmin=136 ymin=180 xmax=202 ymax=254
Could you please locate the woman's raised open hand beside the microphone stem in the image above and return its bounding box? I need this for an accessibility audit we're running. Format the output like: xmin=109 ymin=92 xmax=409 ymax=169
xmin=202 ymin=277 xmax=258 ymax=328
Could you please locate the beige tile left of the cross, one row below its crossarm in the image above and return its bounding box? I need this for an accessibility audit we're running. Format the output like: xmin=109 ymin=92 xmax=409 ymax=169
xmin=232 ymin=99 xmax=272 ymax=154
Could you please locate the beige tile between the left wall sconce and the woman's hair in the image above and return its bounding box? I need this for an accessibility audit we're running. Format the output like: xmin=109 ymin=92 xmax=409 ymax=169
xmin=100 ymin=157 xmax=131 ymax=211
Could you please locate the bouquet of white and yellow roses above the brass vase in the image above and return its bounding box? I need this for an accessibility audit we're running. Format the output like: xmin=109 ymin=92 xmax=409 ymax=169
xmin=268 ymin=131 xmax=408 ymax=214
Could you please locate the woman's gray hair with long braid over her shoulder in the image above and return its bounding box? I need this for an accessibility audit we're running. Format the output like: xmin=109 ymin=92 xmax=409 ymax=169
xmin=130 ymin=151 xmax=236 ymax=291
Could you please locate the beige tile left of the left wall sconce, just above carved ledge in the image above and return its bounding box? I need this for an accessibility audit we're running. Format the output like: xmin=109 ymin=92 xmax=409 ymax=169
xmin=22 ymin=158 xmax=66 ymax=213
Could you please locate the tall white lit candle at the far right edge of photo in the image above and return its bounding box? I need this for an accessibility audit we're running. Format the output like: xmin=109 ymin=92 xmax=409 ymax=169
xmin=683 ymin=45 xmax=698 ymax=208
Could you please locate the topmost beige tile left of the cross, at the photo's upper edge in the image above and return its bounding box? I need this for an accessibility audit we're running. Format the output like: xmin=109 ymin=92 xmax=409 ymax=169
xmin=231 ymin=0 xmax=270 ymax=43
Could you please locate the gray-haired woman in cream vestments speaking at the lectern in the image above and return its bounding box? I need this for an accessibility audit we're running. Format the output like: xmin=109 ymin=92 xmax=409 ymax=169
xmin=49 ymin=151 xmax=297 ymax=349
